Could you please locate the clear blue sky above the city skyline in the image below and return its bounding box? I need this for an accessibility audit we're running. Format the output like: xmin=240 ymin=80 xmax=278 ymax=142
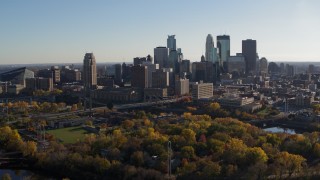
xmin=0 ymin=0 xmax=320 ymax=64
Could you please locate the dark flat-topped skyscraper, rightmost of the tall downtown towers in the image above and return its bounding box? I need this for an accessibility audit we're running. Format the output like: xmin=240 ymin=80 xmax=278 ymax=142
xmin=242 ymin=39 xmax=257 ymax=75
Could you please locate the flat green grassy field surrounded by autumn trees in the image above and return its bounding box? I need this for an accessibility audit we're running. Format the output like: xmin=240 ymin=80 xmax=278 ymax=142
xmin=47 ymin=126 xmax=87 ymax=144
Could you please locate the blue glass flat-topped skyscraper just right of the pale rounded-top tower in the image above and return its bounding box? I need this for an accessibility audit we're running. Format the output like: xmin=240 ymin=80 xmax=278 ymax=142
xmin=217 ymin=35 xmax=230 ymax=72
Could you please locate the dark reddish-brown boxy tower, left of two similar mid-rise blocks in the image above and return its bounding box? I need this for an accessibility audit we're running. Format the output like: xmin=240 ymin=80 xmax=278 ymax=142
xmin=131 ymin=65 xmax=148 ymax=88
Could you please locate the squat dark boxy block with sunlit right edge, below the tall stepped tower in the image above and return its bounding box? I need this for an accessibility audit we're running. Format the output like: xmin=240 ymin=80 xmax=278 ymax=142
xmin=152 ymin=69 xmax=170 ymax=88
